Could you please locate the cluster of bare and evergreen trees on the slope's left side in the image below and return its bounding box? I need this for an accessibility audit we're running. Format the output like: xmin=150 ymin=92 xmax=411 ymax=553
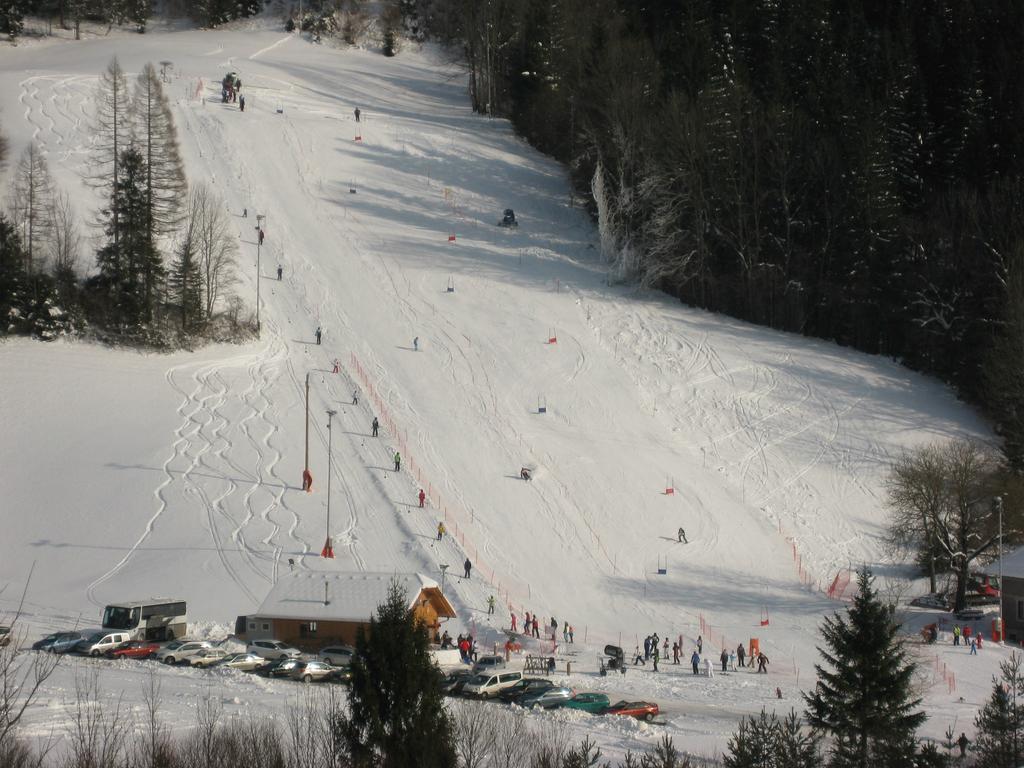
xmin=0 ymin=58 xmax=248 ymax=346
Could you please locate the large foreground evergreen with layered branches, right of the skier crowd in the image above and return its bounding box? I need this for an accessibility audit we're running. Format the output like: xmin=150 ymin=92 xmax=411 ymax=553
xmin=804 ymin=568 xmax=926 ymax=768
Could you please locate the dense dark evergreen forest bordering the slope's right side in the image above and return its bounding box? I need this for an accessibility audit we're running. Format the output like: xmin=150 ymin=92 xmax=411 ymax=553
xmin=401 ymin=0 xmax=1024 ymax=469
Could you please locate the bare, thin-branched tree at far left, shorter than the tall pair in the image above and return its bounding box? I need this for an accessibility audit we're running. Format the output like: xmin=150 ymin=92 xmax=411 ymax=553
xmin=10 ymin=141 xmax=54 ymax=274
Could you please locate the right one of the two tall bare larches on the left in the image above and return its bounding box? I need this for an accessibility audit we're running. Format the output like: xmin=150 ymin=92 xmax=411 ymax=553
xmin=132 ymin=62 xmax=186 ymax=242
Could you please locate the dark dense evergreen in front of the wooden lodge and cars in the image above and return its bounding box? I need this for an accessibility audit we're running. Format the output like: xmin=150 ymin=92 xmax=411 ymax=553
xmin=338 ymin=582 xmax=456 ymax=768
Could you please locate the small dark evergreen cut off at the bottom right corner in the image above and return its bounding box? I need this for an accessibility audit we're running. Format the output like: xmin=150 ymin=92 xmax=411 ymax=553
xmin=974 ymin=653 xmax=1024 ymax=768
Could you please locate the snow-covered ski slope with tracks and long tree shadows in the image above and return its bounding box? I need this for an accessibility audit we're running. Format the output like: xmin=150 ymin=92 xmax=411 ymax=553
xmin=0 ymin=18 xmax=1004 ymax=755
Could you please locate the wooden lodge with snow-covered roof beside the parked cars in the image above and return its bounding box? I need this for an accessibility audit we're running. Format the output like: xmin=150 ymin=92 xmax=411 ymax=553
xmin=240 ymin=570 xmax=456 ymax=651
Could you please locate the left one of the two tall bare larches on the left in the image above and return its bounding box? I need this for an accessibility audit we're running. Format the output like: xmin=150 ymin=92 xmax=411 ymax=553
xmin=92 ymin=56 xmax=131 ymax=246
